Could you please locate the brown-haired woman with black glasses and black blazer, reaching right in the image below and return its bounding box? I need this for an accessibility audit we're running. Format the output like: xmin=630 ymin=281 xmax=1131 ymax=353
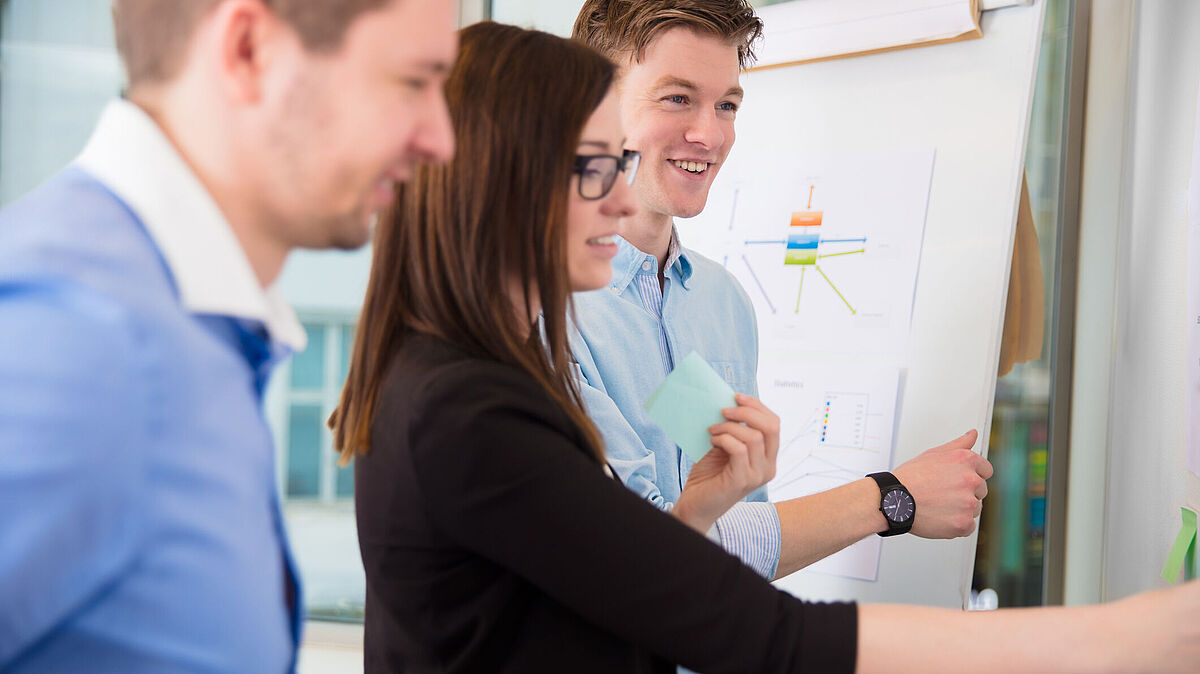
xmin=331 ymin=19 xmax=1200 ymax=673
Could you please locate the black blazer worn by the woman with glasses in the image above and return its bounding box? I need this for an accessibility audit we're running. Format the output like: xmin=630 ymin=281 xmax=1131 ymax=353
xmin=354 ymin=335 xmax=857 ymax=673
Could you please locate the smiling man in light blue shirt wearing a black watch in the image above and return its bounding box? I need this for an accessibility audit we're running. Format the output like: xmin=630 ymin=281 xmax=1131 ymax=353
xmin=572 ymin=0 xmax=991 ymax=578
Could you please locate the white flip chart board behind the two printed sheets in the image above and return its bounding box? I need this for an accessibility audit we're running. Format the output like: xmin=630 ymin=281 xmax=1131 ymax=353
xmin=700 ymin=0 xmax=1044 ymax=608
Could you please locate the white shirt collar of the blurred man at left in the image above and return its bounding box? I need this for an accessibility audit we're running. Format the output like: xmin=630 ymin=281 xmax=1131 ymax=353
xmin=74 ymin=100 xmax=306 ymax=351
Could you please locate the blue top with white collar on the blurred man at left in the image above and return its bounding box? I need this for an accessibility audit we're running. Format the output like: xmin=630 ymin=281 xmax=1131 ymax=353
xmin=0 ymin=102 xmax=302 ymax=673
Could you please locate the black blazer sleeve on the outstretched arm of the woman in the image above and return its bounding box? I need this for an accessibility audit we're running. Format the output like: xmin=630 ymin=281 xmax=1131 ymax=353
xmin=410 ymin=362 xmax=857 ymax=672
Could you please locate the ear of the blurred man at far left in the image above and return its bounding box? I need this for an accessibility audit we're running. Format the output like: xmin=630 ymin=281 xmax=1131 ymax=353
xmin=212 ymin=0 xmax=282 ymax=103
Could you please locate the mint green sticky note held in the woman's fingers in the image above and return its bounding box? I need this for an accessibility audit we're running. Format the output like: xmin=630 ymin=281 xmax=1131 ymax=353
xmin=646 ymin=351 xmax=737 ymax=462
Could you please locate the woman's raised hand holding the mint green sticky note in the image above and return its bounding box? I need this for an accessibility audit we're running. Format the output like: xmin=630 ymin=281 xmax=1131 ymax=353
xmin=673 ymin=393 xmax=779 ymax=534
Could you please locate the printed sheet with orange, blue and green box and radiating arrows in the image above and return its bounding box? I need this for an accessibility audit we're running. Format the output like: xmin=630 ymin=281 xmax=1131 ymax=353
xmin=679 ymin=150 xmax=934 ymax=356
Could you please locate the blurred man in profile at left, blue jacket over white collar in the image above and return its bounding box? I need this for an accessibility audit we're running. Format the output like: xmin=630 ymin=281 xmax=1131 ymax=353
xmin=0 ymin=0 xmax=455 ymax=673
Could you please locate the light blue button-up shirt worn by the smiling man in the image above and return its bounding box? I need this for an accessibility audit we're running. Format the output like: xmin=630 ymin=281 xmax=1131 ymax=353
xmin=571 ymin=233 xmax=780 ymax=578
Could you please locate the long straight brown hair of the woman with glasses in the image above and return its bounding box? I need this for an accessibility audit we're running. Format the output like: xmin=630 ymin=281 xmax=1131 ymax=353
xmin=329 ymin=23 xmax=613 ymax=463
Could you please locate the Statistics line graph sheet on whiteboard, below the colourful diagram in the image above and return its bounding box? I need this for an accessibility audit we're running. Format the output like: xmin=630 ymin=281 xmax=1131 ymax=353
xmin=758 ymin=355 xmax=900 ymax=580
